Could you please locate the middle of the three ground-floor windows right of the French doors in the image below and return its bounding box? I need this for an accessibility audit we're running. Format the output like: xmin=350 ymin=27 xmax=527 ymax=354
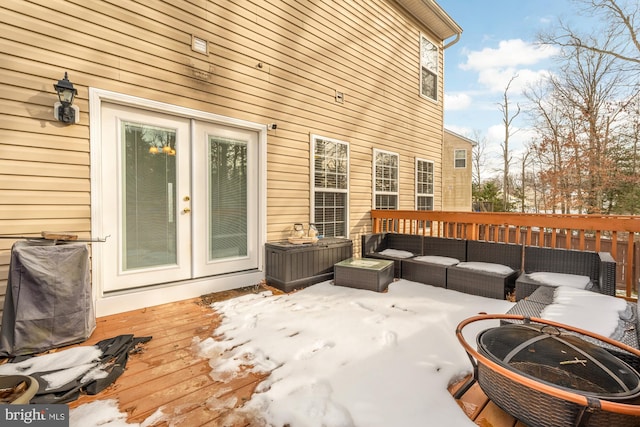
xmin=373 ymin=149 xmax=399 ymax=209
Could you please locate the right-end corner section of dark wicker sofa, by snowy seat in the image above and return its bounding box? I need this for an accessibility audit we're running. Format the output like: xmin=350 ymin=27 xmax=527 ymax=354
xmin=516 ymin=246 xmax=616 ymax=301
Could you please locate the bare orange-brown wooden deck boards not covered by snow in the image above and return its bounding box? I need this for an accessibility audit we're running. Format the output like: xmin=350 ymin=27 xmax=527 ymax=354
xmin=57 ymin=292 xmax=526 ymax=427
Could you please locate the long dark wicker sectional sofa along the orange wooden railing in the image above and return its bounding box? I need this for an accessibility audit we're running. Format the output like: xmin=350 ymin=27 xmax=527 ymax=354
xmin=362 ymin=233 xmax=616 ymax=301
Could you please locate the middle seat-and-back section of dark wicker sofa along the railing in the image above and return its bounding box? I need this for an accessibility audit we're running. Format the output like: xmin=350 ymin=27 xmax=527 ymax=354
xmin=401 ymin=236 xmax=467 ymax=288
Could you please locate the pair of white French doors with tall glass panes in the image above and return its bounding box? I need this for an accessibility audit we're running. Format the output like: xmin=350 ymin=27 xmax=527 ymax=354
xmin=101 ymin=103 xmax=259 ymax=292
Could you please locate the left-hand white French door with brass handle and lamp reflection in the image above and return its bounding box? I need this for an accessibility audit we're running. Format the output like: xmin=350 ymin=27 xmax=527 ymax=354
xmin=98 ymin=103 xmax=192 ymax=292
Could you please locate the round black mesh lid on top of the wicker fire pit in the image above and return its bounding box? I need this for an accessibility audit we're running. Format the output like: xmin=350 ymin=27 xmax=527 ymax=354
xmin=477 ymin=324 xmax=640 ymax=400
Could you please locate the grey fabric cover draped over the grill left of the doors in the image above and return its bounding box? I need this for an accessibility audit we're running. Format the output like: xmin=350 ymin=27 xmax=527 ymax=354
xmin=0 ymin=241 xmax=96 ymax=357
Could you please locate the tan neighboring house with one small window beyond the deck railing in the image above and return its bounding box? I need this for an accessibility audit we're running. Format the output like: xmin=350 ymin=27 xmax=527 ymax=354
xmin=442 ymin=129 xmax=476 ymax=212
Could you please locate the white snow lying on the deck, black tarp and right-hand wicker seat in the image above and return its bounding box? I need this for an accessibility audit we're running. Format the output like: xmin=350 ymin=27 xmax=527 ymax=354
xmin=0 ymin=279 xmax=626 ymax=427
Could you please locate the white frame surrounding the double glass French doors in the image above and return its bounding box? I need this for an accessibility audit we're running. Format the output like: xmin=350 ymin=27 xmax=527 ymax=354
xmin=89 ymin=88 xmax=267 ymax=316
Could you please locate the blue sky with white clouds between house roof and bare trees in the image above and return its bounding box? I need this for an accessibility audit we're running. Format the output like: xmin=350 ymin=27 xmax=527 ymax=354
xmin=437 ymin=0 xmax=590 ymax=176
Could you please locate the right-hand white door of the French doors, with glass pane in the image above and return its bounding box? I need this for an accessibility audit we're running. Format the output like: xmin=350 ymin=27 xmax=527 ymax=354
xmin=192 ymin=121 xmax=259 ymax=277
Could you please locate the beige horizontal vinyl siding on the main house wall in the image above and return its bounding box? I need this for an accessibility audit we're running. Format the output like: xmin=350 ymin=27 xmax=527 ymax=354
xmin=0 ymin=0 xmax=450 ymax=312
